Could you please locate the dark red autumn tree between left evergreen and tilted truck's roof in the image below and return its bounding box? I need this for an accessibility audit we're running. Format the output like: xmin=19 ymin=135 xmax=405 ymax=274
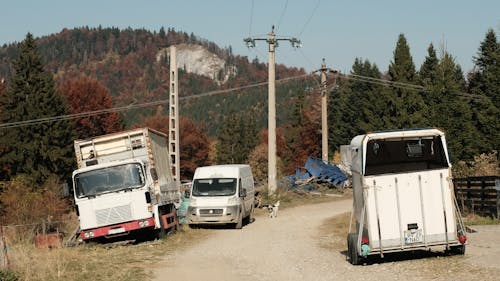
xmin=59 ymin=76 xmax=123 ymax=138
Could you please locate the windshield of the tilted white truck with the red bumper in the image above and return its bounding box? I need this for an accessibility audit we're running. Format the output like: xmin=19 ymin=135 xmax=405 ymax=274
xmin=74 ymin=163 xmax=144 ymax=198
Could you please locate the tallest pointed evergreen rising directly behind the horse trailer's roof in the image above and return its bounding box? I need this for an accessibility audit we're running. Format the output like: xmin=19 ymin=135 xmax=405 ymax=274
xmin=388 ymin=34 xmax=427 ymax=128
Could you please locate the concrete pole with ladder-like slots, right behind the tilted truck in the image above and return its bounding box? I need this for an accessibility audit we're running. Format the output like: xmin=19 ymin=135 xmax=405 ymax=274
xmin=168 ymin=45 xmax=181 ymax=181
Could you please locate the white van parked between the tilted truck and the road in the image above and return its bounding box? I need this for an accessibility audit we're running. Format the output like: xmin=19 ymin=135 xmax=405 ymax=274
xmin=187 ymin=164 xmax=255 ymax=229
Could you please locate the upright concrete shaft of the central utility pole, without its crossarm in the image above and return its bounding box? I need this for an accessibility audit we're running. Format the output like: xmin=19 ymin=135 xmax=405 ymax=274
xmin=268 ymin=30 xmax=277 ymax=196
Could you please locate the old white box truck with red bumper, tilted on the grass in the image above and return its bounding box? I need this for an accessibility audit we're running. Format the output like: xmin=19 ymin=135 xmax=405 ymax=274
xmin=73 ymin=128 xmax=180 ymax=241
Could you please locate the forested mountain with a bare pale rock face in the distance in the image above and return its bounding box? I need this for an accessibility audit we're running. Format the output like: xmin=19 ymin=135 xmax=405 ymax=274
xmin=0 ymin=26 xmax=305 ymax=130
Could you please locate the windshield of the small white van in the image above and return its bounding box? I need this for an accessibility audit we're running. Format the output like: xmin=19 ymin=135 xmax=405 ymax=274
xmin=192 ymin=178 xmax=236 ymax=196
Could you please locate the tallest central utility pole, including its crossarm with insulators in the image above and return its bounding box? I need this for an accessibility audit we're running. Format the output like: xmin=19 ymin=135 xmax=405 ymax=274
xmin=243 ymin=26 xmax=301 ymax=196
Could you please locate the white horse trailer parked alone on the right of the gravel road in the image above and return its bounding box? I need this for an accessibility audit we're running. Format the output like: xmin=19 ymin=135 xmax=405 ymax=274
xmin=347 ymin=129 xmax=466 ymax=264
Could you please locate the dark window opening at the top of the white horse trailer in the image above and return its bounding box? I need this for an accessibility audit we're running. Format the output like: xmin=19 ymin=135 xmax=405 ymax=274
xmin=365 ymin=136 xmax=449 ymax=175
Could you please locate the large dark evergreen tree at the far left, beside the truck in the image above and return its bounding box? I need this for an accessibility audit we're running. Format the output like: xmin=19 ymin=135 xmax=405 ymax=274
xmin=0 ymin=33 xmax=74 ymax=183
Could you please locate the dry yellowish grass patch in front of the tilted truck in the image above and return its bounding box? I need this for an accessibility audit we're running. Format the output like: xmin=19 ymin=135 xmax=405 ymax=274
xmin=9 ymin=227 xmax=209 ymax=281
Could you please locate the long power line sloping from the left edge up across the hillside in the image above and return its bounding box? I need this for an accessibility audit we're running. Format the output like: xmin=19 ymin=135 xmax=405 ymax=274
xmin=0 ymin=74 xmax=311 ymax=129
